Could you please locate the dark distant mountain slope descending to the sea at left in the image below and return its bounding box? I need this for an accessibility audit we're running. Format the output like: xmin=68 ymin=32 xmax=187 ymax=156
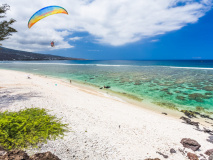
xmin=0 ymin=47 xmax=85 ymax=61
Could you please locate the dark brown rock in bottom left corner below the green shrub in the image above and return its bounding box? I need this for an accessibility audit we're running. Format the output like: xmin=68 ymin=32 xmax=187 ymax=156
xmin=0 ymin=150 xmax=30 ymax=160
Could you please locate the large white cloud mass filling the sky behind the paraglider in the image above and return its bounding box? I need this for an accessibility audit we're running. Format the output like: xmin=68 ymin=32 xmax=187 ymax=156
xmin=1 ymin=0 xmax=213 ymax=51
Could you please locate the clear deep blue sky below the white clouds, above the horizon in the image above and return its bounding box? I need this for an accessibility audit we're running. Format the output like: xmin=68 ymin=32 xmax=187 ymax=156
xmin=46 ymin=7 xmax=213 ymax=60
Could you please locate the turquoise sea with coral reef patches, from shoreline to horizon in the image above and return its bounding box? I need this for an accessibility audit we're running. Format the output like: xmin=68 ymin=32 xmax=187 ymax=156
xmin=0 ymin=61 xmax=213 ymax=111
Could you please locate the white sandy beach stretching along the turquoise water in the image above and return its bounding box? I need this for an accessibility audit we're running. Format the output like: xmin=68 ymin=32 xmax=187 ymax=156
xmin=0 ymin=70 xmax=213 ymax=160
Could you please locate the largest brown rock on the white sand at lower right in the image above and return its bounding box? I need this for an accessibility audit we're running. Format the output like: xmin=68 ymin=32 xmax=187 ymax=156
xmin=180 ymin=138 xmax=201 ymax=151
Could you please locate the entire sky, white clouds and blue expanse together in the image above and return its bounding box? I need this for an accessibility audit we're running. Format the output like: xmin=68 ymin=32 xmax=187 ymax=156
xmin=3 ymin=0 xmax=213 ymax=60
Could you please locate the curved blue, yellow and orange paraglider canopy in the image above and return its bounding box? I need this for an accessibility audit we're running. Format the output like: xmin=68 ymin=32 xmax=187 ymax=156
xmin=28 ymin=6 xmax=68 ymax=28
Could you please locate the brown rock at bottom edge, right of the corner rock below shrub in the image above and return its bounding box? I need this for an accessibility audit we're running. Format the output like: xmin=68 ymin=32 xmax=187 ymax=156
xmin=30 ymin=152 xmax=60 ymax=160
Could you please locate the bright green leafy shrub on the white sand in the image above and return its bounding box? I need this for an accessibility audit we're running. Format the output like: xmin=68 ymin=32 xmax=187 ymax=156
xmin=0 ymin=108 xmax=68 ymax=150
